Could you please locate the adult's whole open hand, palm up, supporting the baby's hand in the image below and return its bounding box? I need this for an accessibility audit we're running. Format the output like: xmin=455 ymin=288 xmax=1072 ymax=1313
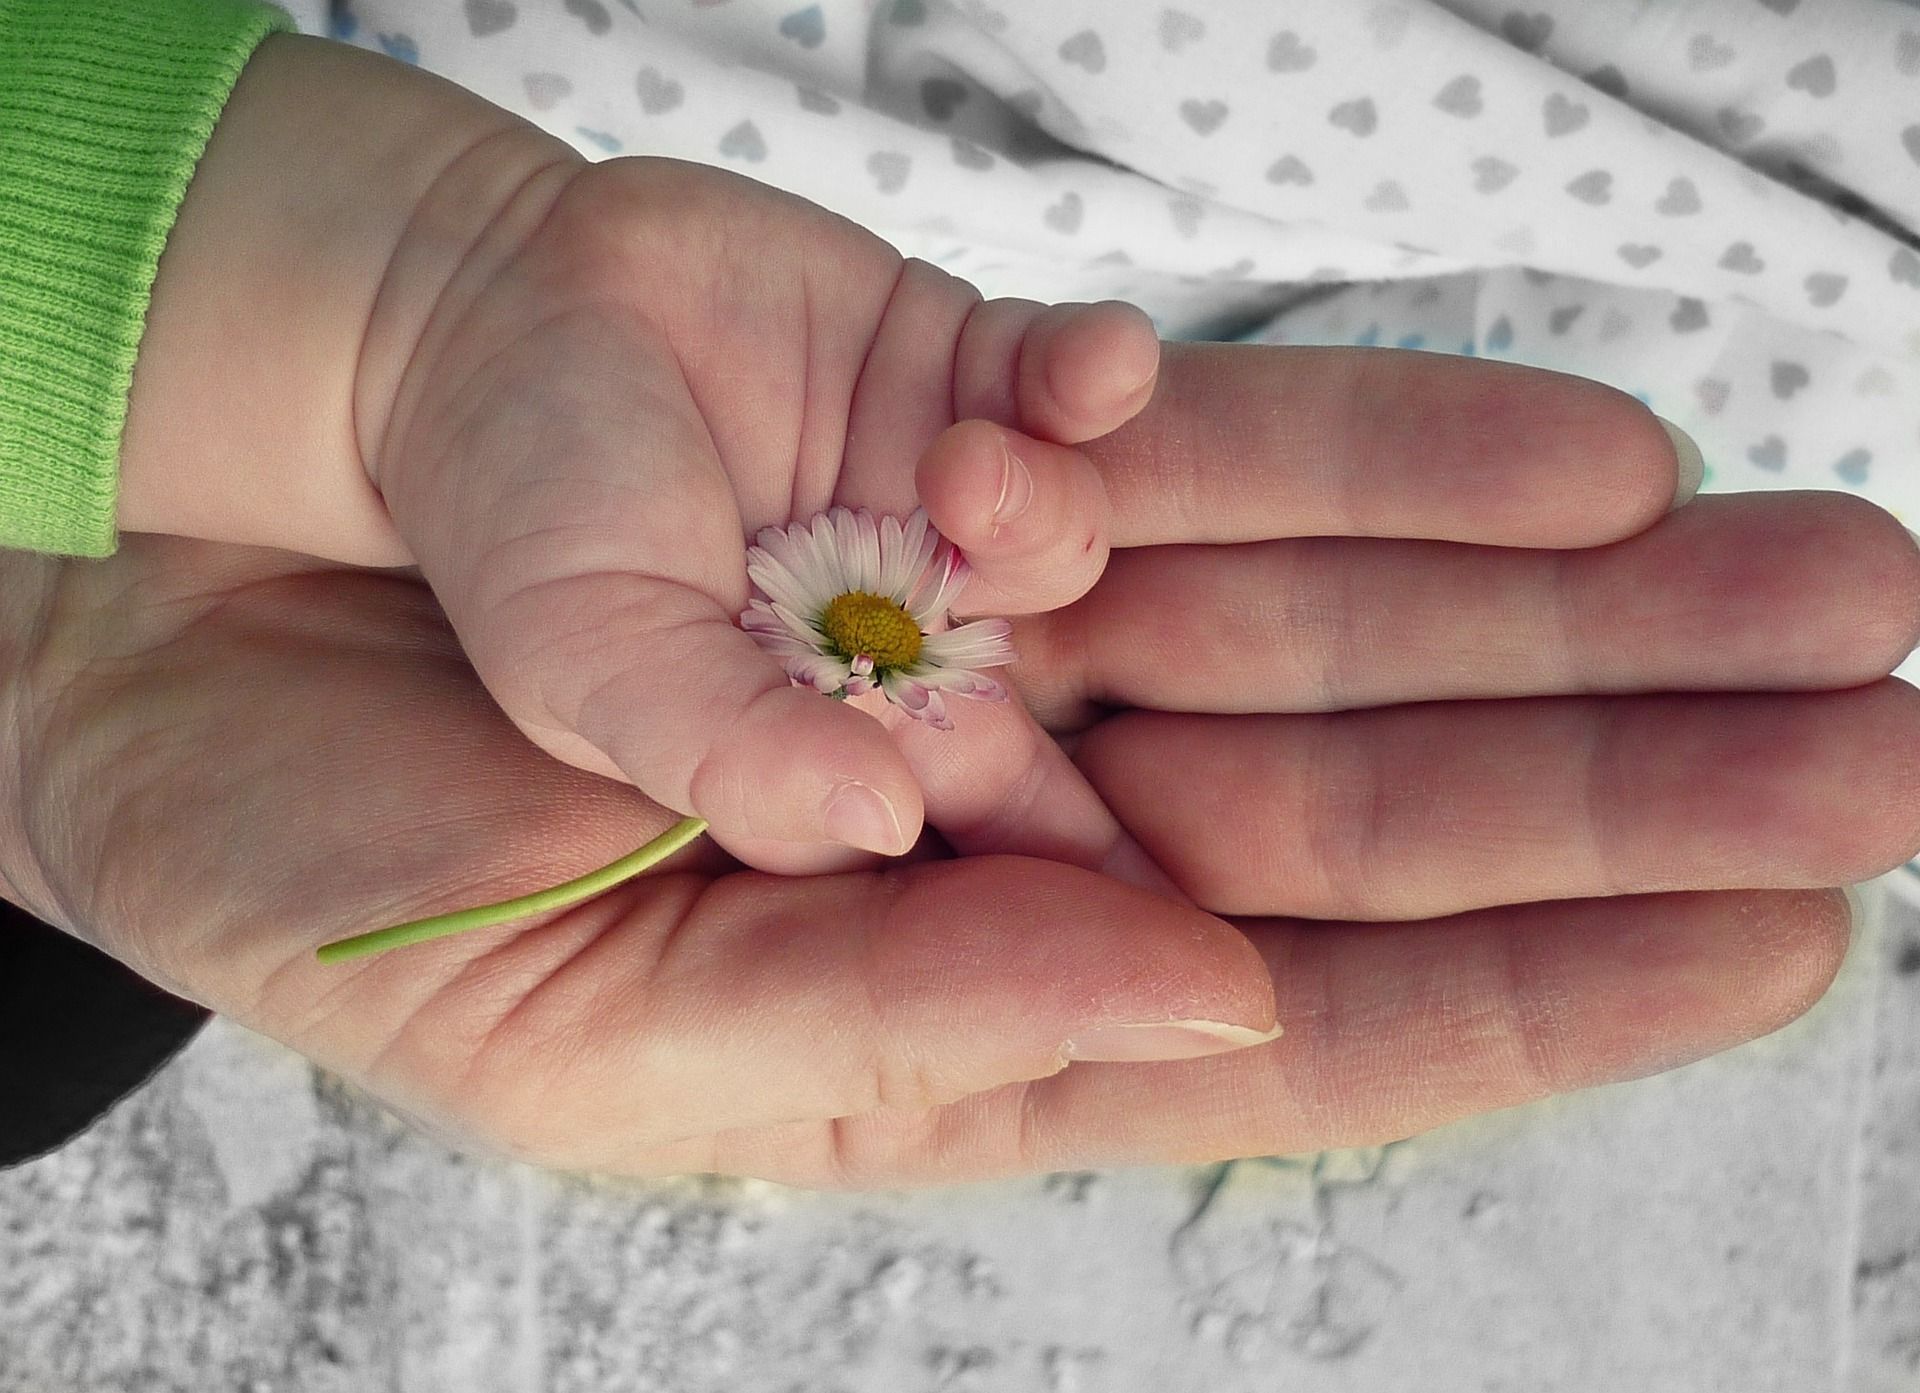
xmin=0 ymin=345 xmax=1920 ymax=1186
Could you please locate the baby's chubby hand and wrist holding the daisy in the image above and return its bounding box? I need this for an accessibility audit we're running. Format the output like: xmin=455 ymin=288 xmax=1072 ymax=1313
xmin=121 ymin=36 xmax=1160 ymax=873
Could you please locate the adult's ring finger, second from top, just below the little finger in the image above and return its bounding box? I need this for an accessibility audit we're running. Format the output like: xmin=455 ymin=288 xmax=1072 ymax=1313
xmin=1018 ymin=491 xmax=1920 ymax=729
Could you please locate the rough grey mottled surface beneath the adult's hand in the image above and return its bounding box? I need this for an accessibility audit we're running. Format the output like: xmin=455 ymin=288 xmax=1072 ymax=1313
xmin=0 ymin=878 xmax=1920 ymax=1393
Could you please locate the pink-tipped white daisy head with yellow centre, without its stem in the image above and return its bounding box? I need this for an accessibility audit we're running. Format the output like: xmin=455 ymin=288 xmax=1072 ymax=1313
xmin=739 ymin=508 xmax=1014 ymax=731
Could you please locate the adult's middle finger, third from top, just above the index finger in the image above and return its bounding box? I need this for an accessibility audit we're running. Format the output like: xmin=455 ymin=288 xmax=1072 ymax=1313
xmin=1075 ymin=690 xmax=1920 ymax=919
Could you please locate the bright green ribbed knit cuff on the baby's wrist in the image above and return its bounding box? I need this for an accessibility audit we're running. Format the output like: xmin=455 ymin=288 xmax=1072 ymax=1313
xmin=0 ymin=0 xmax=296 ymax=556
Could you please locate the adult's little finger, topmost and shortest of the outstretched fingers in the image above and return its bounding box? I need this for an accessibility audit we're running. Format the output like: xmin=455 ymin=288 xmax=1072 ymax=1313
xmin=1085 ymin=343 xmax=1701 ymax=547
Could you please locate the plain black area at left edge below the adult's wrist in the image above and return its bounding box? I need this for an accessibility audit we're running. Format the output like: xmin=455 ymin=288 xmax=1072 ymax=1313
xmin=0 ymin=900 xmax=211 ymax=1169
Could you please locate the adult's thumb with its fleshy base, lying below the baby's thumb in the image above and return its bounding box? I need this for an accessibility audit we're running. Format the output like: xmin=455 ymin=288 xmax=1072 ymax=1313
xmin=359 ymin=858 xmax=1275 ymax=1174
